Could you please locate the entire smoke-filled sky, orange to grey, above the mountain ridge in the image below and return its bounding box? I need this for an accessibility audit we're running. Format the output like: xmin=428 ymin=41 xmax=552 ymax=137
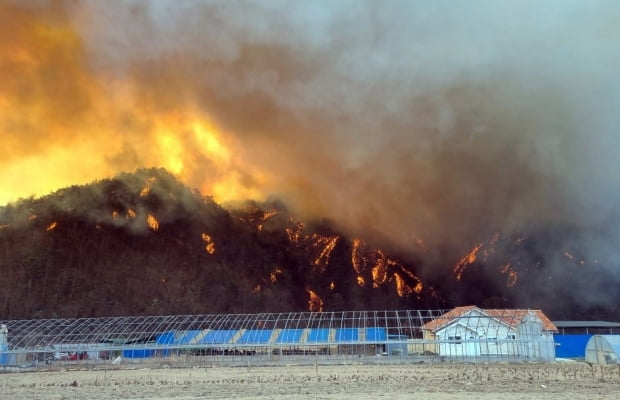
xmin=0 ymin=1 xmax=620 ymax=276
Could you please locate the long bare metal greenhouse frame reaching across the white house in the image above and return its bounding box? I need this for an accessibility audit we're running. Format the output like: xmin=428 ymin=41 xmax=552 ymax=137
xmin=0 ymin=310 xmax=548 ymax=371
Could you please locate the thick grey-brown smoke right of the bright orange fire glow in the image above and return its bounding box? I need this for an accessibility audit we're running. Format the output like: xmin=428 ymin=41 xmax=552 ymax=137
xmin=4 ymin=0 xmax=620 ymax=286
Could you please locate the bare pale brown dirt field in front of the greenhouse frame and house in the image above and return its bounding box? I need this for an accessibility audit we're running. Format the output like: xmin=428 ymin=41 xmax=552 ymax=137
xmin=0 ymin=362 xmax=620 ymax=400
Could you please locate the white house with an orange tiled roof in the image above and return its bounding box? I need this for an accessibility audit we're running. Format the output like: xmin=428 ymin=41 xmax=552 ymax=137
xmin=422 ymin=306 xmax=557 ymax=361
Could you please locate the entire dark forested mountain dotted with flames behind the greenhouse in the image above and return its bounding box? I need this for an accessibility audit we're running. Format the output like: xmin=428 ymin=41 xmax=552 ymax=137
xmin=0 ymin=169 xmax=620 ymax=319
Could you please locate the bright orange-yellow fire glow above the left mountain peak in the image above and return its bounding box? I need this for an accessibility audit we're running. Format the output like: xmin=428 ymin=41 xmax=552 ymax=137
xmin=0 ymin=2 xmax=265 ymax=204
